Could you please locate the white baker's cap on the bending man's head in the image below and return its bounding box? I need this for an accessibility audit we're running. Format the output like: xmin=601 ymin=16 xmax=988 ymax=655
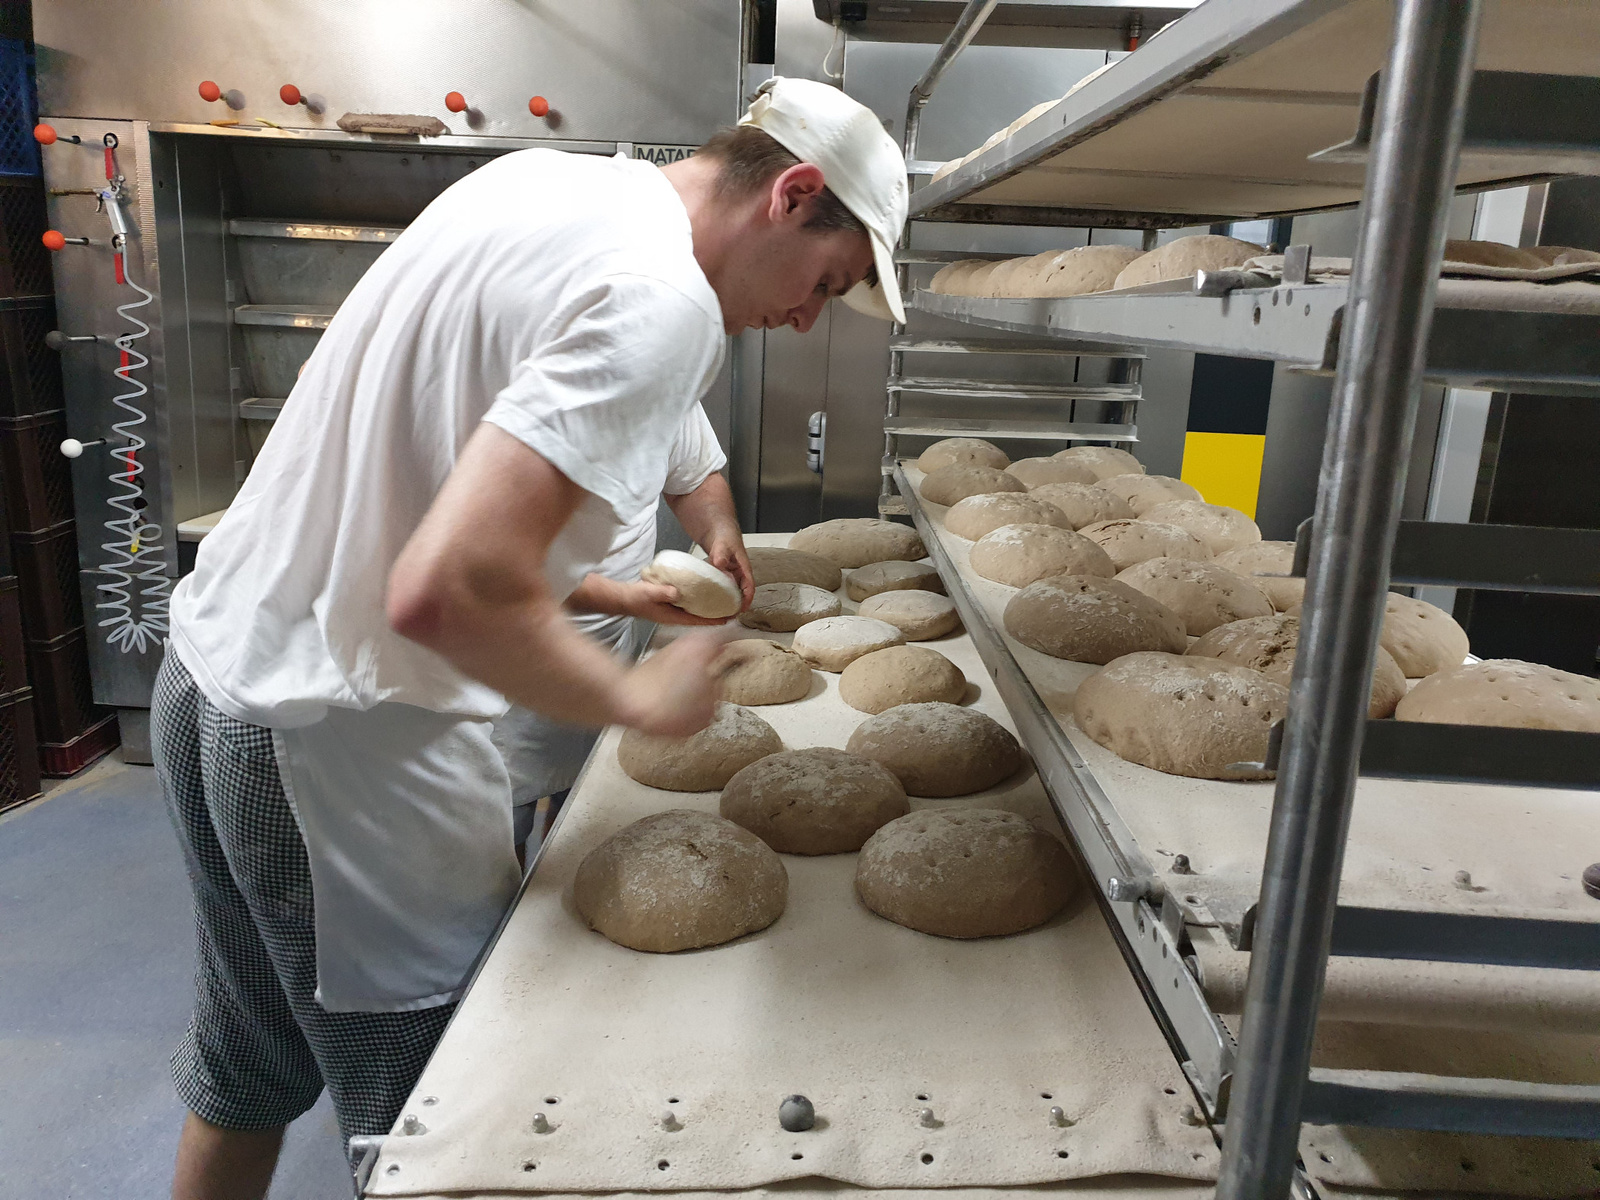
xmin=739 ymin=75 xmax=907 ymax=323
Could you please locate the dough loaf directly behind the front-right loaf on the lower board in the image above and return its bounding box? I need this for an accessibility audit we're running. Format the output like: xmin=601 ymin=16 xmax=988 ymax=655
xmin=845 ymin=702 xmax=1022 ymax=798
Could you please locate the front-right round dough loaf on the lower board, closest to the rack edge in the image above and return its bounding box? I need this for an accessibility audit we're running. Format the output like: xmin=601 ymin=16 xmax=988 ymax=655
xmin=856 ymin=808 xmax=1080 ymax=938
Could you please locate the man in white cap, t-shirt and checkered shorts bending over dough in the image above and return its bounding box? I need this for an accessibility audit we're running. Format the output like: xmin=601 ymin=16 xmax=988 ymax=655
xmin=152 ymin=78 xmax=906 ymax=1200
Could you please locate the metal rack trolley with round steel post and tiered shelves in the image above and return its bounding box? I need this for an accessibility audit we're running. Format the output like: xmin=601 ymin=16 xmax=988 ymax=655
xmin=885 ymin=0 xmax=1600 ymax=1200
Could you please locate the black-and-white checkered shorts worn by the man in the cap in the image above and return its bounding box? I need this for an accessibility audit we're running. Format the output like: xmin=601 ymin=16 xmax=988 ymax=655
xmin=150 ymin=650 xmax=454 ymax=1141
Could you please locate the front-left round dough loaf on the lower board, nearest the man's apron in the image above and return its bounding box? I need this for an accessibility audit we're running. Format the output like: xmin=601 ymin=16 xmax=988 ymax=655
xmin=573 ymin=808 xmax=789 ymax=954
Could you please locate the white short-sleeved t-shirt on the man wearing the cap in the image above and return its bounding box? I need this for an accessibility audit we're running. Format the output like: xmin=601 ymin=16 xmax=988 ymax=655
xmin=171 ymin=150 xmax=725 ymax=728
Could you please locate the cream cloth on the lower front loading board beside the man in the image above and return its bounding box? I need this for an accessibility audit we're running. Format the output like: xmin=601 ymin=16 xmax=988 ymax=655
xmin=368 ymin=536 xmax=1218 ymax=1197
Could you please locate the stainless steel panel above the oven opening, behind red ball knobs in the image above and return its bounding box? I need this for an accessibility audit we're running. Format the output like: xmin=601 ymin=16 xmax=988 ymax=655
xmin=34 ymin=0 xmax=741 ymax=146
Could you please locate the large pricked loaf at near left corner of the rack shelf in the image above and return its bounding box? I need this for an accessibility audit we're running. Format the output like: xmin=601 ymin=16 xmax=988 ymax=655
xmin=1072 ymin=653 xmax=1290 ymax=779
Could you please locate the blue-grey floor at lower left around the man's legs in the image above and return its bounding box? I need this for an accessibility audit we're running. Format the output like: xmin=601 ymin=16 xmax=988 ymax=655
xmin=0 ymin=757 xmax=350 ymax=1200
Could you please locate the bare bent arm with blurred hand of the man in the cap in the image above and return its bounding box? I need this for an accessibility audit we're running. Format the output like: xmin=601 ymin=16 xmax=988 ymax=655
xmin=387 ymin=424 xmax=720 ymax=734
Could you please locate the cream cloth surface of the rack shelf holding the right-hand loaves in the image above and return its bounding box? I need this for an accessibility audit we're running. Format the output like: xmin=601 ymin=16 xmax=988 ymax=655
xmin=904 ymin=462 xmax=1600 ymax=928
